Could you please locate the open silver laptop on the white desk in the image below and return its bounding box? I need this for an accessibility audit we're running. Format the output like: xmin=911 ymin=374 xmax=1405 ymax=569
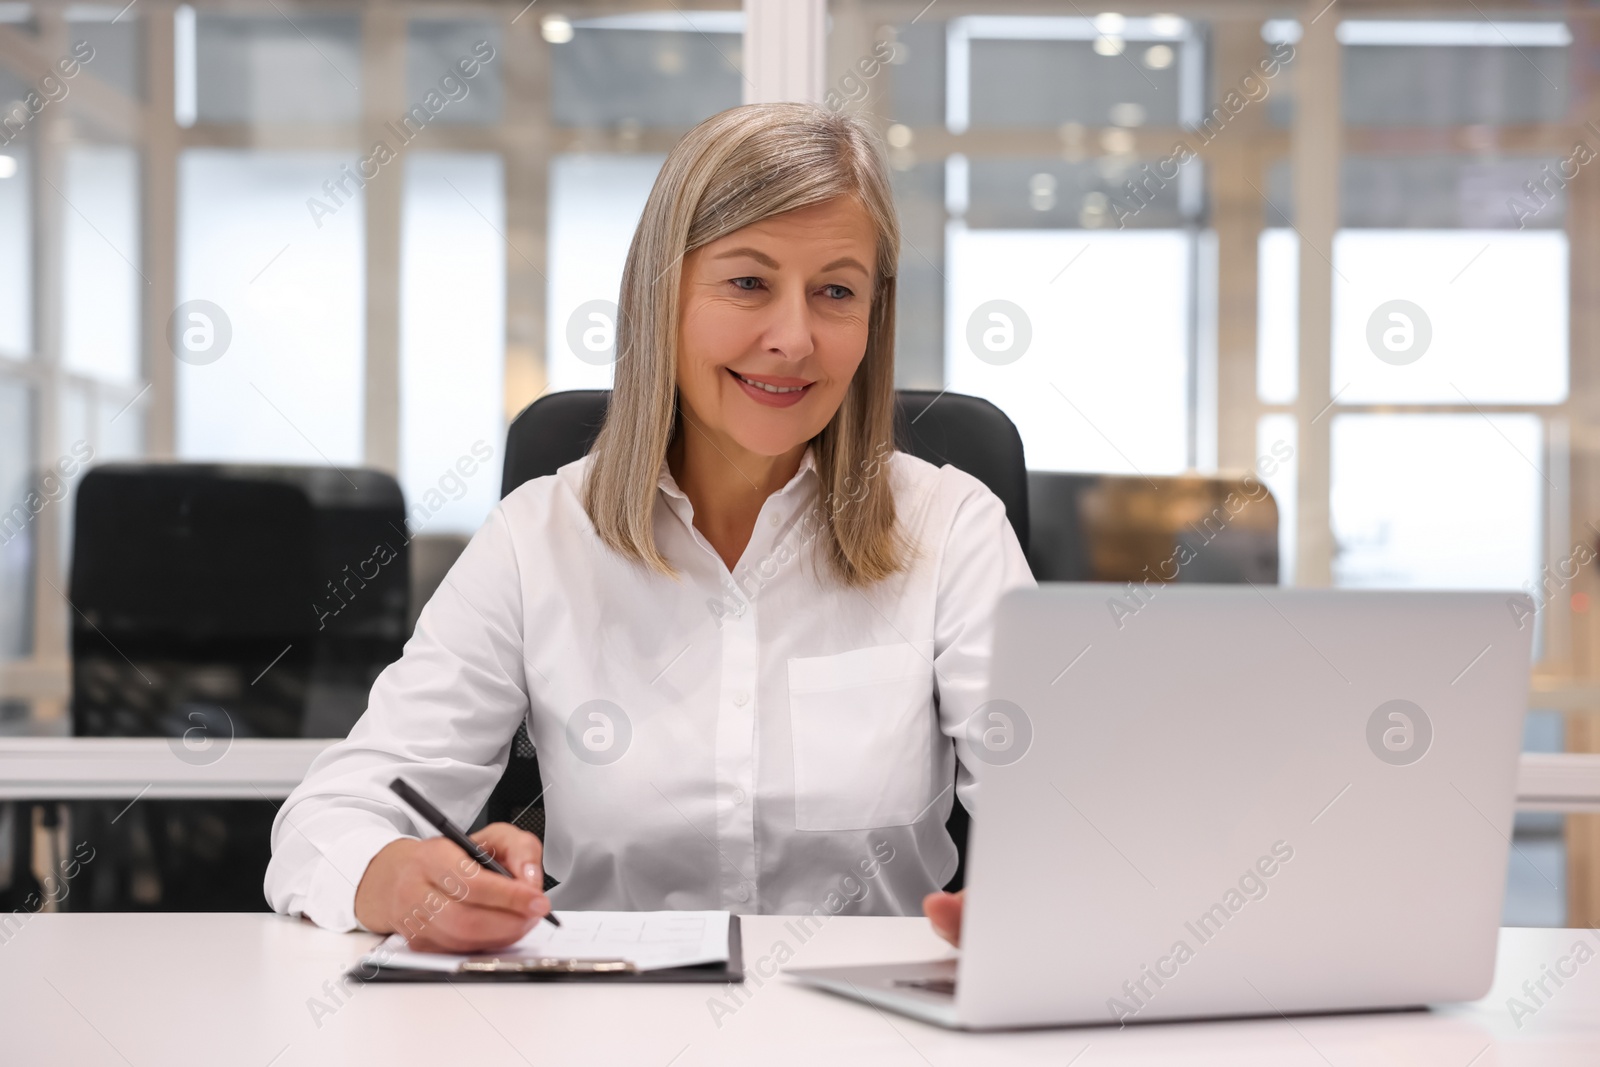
xmin=787 ymin=585 xmax=1533 ymax=1029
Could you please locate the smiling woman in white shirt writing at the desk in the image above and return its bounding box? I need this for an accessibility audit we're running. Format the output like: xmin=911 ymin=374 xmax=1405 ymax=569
xmin=266 ymin=104 xmax=1032 ymax=952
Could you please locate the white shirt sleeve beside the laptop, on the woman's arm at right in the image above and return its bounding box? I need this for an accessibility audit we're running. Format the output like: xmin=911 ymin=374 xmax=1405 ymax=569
xmin=933 ymin=467 xmax=1037 ymax=816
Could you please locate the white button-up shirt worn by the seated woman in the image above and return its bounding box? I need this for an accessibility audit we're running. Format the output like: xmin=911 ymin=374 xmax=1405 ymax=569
xmin=266 ymin=450 xmax=1034 ymax=929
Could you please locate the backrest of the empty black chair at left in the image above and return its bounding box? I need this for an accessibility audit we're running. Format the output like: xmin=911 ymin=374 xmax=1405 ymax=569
xmin=69 ymin=462 xmax=410 ymax=737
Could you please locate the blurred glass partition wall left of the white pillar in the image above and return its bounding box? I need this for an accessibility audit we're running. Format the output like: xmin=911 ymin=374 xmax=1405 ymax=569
xmin=0 ymin=0 xmax=744 ymax=733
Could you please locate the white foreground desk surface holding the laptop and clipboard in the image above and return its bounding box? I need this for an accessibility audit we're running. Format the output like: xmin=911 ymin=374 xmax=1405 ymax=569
xmin=0 ymin=915 xmax=1600 ymax=1067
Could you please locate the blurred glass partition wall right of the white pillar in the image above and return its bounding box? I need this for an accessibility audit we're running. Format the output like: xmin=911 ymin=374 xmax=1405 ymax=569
xmin=829 ymin=0 xmax=1600 ymax=923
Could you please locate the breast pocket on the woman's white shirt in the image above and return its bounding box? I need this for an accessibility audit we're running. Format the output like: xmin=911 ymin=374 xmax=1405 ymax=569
xmin=789 ymin=641 xmax=939 ymax=830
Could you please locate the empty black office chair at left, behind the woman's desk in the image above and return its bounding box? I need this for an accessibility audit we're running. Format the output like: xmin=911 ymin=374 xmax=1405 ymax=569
xmin=53 ymin=464 xmax=410 ymax=910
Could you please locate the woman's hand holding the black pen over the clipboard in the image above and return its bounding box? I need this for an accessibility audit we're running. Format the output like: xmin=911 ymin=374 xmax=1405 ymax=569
xmin=355 ymin=822 xmax=550 ymax=952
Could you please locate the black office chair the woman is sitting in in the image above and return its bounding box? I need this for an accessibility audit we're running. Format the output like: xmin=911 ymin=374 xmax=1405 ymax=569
xmin=485 ymin=389 xmax=1029 ymax=891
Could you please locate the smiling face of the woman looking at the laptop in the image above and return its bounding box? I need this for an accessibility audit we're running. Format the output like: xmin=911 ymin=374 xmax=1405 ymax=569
xmin=678 ymin=197 xmax=877 ymax=456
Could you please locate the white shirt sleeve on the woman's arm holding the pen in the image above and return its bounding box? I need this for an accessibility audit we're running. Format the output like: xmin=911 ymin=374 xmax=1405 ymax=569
xmin=266 ymin=506 xmax=528 ymax=931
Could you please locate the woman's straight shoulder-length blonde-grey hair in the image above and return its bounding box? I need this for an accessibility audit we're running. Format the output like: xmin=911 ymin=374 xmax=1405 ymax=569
xmin=584 ymin=104 xmax=910 ymax=587
